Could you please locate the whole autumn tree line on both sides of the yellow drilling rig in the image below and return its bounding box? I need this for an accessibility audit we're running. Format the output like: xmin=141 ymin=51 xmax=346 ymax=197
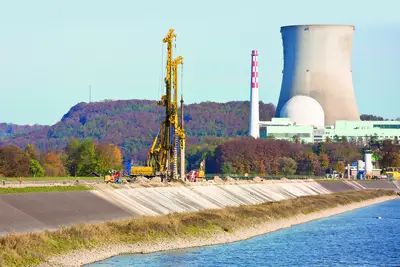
xmin=0 ymin=137 xmax=400 ymax=177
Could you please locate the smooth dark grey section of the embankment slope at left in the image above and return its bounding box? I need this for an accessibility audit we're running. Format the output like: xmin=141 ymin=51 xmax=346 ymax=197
xmin=0 ymin=192 xmax=130 ymax=235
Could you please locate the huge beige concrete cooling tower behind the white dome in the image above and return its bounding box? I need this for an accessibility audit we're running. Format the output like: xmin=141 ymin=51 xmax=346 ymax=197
xmin=276 ymin=25 xmax=360 ymax=125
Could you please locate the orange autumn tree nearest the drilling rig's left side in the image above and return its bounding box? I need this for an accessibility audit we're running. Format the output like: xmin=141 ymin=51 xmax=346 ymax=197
xmin=96 ymin=143 xmax=122 ymax=173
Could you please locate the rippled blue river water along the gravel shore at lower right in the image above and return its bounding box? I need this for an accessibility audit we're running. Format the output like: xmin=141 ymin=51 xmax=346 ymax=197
xmin=87 ymin=200 xmax=400 ymax=267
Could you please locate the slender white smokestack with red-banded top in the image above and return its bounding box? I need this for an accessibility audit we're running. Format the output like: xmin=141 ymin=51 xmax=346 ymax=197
xmin=249 ymin=50 xmax=260 ymax=138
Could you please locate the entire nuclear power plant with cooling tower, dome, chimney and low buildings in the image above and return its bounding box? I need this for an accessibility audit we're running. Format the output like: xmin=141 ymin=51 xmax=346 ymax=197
xmin=249 ymin=25 xmax=400 ymax=144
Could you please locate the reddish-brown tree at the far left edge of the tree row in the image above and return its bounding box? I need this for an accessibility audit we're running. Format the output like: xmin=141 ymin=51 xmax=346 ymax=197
xmin=0 ymin=146 xmax=30 ymax=177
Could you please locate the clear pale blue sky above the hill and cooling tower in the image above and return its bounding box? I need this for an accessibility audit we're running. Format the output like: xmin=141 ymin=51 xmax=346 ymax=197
xmin=0 ymin=0 xmax=400 ymax=124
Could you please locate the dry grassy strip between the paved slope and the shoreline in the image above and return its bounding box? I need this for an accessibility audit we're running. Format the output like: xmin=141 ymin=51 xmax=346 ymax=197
xmin=0 ymin=190 xmax=395 ymax=266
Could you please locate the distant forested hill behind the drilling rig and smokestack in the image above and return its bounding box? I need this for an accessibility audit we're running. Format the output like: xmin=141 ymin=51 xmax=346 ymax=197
xmin=0 ymin=100 xmax=275 ymax=159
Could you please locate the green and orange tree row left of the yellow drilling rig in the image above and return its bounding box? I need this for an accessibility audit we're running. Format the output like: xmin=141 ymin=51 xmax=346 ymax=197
xmin=0 ymin=139 xmax=122 ymax=177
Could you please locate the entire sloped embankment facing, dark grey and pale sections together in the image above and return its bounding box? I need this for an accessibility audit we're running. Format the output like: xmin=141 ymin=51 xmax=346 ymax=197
xmin=0 ymin=181 xmax=400 ymax=235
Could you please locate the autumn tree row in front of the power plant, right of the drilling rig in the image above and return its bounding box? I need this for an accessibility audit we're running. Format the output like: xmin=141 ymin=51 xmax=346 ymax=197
xmin=187 ymin=138 xmax=400 ymax=176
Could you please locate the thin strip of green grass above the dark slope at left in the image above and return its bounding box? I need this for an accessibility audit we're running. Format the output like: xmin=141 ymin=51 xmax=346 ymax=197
xmin=0 ymin=185 xmax=93 ymax=195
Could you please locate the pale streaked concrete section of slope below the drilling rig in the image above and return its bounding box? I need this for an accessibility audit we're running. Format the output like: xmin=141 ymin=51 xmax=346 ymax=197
xmin=94 ymin=182 xmax=330 ymax=215
